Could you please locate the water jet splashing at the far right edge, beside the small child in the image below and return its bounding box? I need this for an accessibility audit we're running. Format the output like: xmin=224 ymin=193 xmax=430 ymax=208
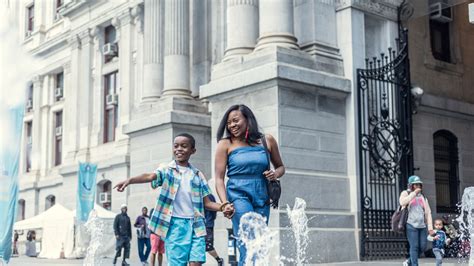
xmin=456 ymin=187 xmax=474 ymax=266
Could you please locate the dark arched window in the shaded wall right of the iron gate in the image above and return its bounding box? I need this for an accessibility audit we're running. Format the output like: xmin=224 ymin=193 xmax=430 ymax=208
xmin=433 ymin=130 xmax=459 ymax=212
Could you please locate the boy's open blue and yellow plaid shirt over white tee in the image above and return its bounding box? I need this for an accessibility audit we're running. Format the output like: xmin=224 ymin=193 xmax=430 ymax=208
xmin=148 ymin=160 xmax=211 ymax=239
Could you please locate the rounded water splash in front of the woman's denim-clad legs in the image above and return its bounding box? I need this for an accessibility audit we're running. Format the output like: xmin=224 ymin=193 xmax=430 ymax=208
xmin=239 ymin=212 xmax=277 ymax=266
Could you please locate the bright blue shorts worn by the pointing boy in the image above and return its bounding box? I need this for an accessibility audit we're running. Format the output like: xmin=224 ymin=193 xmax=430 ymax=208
xmin=165 ymin=217 xmax=206 ymax=266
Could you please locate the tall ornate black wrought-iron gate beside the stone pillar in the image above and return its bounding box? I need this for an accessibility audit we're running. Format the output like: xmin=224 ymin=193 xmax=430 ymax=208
xmin=357 ymin=26 xmax=413 ymax=260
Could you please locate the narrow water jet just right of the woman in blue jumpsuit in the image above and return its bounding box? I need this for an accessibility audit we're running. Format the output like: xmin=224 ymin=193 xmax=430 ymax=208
xmin=286 ymin=198 xmax=309 ymax=265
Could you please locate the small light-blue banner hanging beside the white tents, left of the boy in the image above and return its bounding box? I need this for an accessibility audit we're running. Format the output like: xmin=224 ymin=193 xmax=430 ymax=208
xmin=76 ymin=163 xmax=97 ymax=222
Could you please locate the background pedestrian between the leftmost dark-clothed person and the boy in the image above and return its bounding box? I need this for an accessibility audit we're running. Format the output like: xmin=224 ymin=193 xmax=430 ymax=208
xmin=134 ymin=207 xmax=151 ymax=265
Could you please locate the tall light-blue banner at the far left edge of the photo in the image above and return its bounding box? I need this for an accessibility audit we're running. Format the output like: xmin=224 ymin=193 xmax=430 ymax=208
xmin=0 ymin=105 xmax=25 ymax=263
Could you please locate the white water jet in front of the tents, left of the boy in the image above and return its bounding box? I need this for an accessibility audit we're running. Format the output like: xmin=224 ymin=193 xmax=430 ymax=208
xmin=83 ymin=210 xmax=104 ymax=266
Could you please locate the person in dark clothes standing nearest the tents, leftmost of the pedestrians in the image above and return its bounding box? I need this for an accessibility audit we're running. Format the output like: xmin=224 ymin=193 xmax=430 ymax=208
xmin=114 ymin=204 xmax=132 ymax=266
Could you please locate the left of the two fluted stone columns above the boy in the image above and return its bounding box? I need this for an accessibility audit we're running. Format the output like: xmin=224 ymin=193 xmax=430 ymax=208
xmin=141 ymin=0 xmax=164 ymax=101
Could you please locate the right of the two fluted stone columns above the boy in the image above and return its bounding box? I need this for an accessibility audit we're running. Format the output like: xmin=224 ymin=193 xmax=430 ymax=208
xmin=163 ymin=0 xmax=191 ymax=97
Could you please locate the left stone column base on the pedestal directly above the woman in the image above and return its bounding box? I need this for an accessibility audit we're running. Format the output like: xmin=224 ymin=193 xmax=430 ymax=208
xmin=224 ymin=0 xmax=258 ymax=60
